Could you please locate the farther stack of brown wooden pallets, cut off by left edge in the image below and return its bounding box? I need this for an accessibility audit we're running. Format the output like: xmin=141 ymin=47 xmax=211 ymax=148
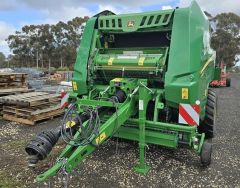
xmin=0 ymin=73 xmax=28 ymax=96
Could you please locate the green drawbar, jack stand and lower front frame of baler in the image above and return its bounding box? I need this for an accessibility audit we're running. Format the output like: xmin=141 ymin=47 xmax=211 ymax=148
xmin=37 ymin=79 xmax=205 ymax=182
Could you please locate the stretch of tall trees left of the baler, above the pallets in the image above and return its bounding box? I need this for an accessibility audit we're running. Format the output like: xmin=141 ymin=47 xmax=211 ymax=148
xmin=1 ymin=17 xmax=88 ymax=68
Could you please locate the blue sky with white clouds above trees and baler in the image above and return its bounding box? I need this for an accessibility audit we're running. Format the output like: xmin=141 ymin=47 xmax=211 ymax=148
xmin=0 ymin=0 xmax=240 ymax=55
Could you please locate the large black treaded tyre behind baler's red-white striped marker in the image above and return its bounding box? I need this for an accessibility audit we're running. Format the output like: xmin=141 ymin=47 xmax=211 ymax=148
xmin=198 ymin=90 xmax=217 ymax=138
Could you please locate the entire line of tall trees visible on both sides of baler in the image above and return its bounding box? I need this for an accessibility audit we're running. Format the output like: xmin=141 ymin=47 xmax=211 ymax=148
xmin=0 ymin=12 xmax=240 ymax=69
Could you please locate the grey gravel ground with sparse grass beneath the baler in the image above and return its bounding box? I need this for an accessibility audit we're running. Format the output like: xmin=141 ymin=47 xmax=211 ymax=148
xmin=0 ymin=75 xmax=240 ymax=188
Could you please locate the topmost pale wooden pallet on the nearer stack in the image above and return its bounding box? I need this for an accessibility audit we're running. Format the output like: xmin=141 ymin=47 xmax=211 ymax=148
xmin=0 ymin=92 xmax=61 ymax=107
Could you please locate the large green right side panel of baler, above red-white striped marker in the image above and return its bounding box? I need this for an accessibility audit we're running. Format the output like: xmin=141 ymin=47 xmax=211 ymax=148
xmin=165 ymin=1 xmax=214 ymax=117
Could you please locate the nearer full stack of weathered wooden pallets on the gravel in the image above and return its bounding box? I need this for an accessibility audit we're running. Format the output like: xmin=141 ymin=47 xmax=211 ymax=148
xmin=0 ymin=92 xmax=64 ymax=125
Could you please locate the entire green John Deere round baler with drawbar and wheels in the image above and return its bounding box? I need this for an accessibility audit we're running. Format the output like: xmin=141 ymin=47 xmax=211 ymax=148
xmin=25 ymin=1 xmax=217 ymax=182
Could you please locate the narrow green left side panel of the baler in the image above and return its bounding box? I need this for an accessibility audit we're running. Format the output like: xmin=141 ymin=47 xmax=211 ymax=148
xmin=72 ymin=18 xmax=97 ymax=94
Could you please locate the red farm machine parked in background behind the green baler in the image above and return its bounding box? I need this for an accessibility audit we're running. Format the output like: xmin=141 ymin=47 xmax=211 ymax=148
xmin=210 ymin=61 xmax=231 ymax=87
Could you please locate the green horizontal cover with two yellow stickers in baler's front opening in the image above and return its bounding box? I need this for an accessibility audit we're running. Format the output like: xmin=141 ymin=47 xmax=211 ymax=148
xmin=94 ymin=47 xmax=168 ymax=74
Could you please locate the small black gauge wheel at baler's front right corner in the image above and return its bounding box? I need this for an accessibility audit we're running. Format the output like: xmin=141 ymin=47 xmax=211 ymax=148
xmin=200 ymin=140 xmax=212 ymax=167
